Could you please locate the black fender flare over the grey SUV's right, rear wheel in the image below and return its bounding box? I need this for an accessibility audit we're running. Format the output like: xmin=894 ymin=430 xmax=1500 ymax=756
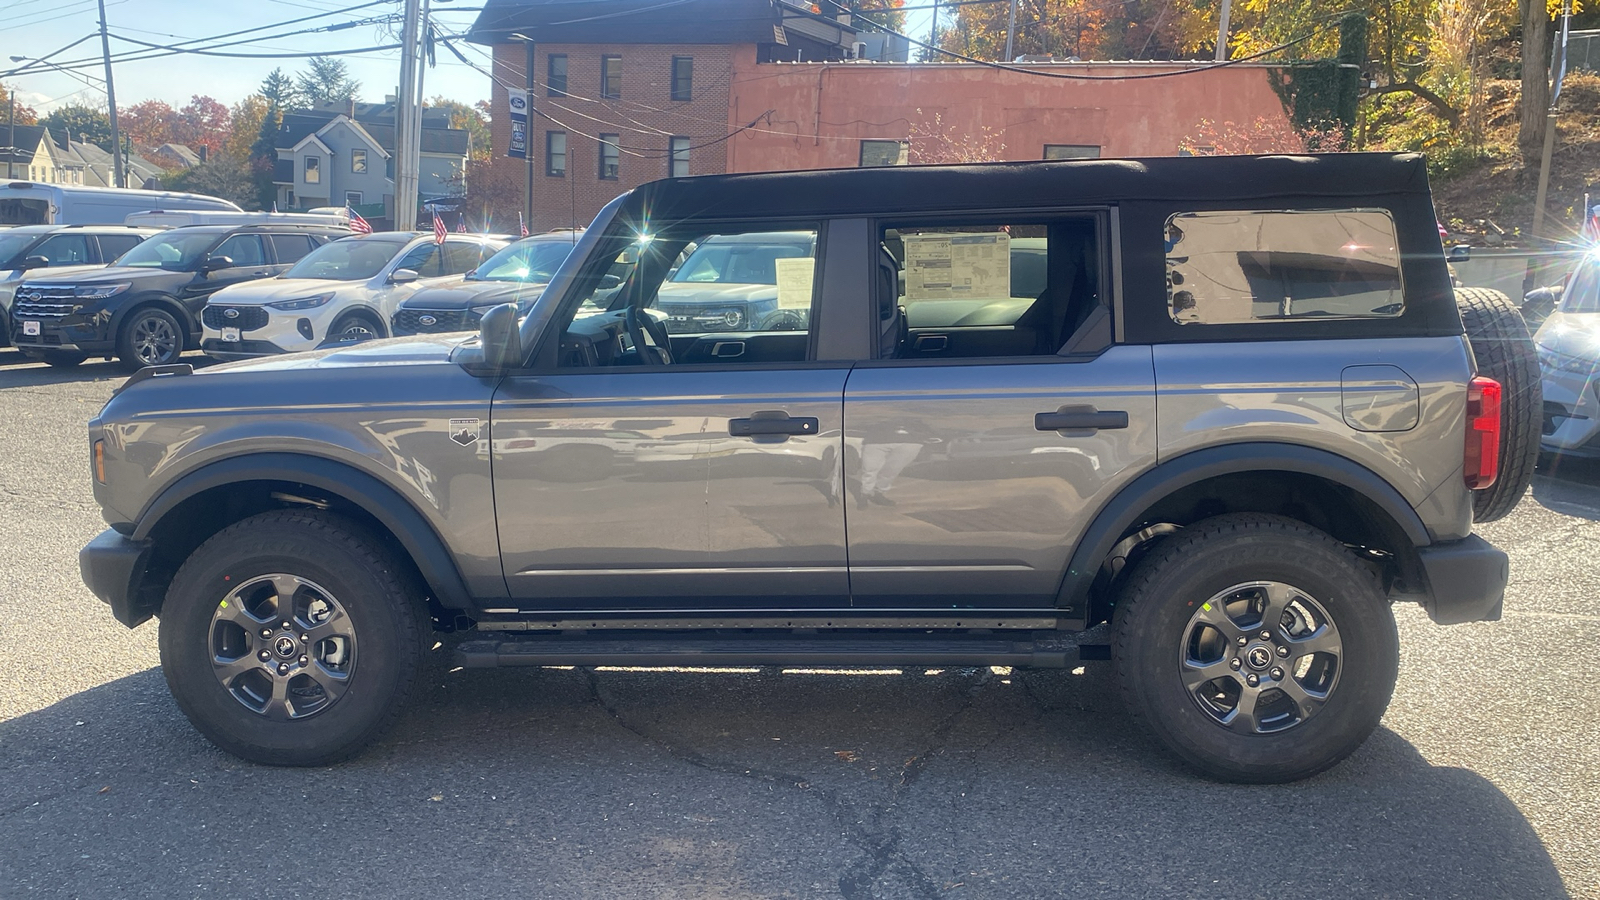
xmin=1056 ymin=442 xmax=1434 ymax=615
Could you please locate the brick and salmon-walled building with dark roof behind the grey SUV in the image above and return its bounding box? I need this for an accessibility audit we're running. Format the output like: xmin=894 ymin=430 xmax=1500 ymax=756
xmin=470 ymin=0 xmax=1286 ymax=231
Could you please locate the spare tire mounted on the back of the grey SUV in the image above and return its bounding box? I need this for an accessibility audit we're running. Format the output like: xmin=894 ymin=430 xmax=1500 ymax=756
xmin=1456 ymin=288 xmax=1544 ymax=522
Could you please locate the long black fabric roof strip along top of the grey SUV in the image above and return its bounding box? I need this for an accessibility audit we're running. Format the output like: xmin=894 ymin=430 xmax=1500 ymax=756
xmin=621 ymin=154 xmax=1427 ymax=221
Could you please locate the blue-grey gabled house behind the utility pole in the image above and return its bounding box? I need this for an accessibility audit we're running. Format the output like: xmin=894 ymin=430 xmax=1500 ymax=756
xmin=274 ymin=99 xmax=470 ymax=224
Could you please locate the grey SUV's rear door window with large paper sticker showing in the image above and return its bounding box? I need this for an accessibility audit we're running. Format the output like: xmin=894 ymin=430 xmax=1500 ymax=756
xmin=875 ymin=213 xmax=1112 ymax=359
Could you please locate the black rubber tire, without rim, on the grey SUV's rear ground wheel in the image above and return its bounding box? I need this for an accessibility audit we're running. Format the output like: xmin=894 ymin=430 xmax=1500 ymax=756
xmin=1112 ymin=514 xmax=1400 ymax=783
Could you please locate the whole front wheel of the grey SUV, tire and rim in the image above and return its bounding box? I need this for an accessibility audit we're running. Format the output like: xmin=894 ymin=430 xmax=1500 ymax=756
xmin=160 ymin=511 xmax=422 ymax=765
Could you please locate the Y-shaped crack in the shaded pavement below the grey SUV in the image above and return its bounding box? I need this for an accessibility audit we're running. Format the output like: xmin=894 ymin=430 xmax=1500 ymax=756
xmin=579 ymin=668 xmax=992 ymax=900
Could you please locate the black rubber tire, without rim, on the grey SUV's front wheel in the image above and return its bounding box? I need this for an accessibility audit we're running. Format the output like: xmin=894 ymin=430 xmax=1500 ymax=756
xmin=160 ymin=509 xmax=426 ymax=765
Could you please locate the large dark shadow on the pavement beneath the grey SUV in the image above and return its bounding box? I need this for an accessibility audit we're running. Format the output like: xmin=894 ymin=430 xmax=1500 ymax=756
xmin=0 ymin=668 xmax=1566 ymax=898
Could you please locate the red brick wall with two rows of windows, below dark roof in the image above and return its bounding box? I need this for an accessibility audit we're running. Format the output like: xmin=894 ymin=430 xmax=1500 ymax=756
xmin=490 ymin=43 xmax=734 ymax=231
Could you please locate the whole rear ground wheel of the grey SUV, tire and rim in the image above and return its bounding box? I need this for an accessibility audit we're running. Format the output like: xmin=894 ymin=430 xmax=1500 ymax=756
xmin=1112 ymin=514 xmax=1400 ymax=783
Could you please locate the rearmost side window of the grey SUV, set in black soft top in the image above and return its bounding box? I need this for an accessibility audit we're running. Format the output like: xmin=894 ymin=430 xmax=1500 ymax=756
xmin=1166 ymin=210 xmax=1405 ymax=325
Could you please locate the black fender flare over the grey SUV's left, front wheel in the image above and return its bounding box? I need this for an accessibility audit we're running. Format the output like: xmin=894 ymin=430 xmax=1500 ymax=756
xmin=128 ymin=453 xmax=470 ymax=609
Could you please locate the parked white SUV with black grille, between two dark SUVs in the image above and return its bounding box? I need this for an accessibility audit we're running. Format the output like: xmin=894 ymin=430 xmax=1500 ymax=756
xmin=200 ymin=231 xmax=506 ymax=359
